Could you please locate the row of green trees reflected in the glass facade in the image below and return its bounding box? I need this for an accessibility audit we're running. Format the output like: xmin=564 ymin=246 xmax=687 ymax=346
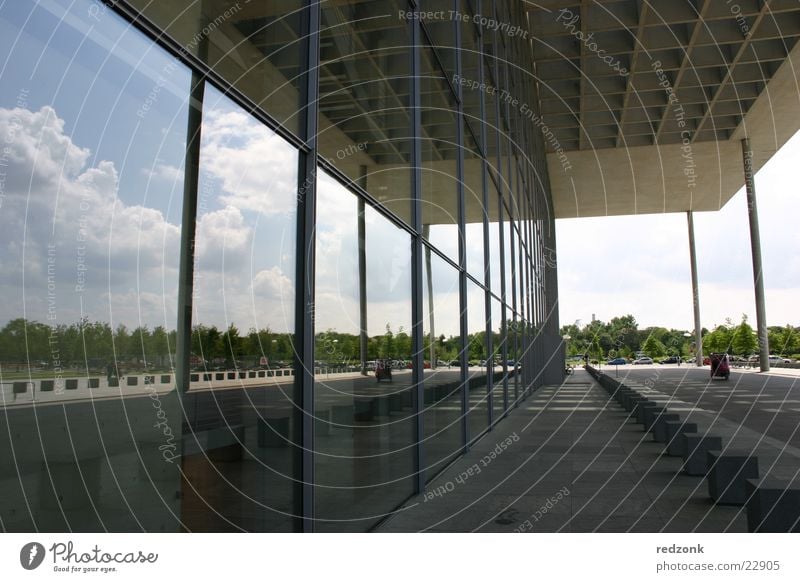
xmin=0 ymin=318 xmax=536 ymax=371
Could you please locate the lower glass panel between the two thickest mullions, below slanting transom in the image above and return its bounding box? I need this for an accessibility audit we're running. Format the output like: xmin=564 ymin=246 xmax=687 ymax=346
xmin=314 ymin=172 xmax=415 ymax=531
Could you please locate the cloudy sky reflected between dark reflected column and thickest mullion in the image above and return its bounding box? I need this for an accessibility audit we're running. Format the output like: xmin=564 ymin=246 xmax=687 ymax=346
xmin=195 ymin=86 xmax=298 ymax=332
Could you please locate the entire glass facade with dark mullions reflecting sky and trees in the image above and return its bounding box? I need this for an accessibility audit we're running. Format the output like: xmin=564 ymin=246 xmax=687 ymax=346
xmin=0 ymin=0 xmax=557 ymax=532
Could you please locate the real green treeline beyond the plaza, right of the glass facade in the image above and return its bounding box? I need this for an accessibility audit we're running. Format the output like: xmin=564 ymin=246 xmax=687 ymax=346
xmin=561 ymin=315 xmax=800 ymax=360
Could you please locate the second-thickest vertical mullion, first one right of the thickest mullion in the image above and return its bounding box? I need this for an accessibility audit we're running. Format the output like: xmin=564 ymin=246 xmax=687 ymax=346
xmin=408 ymin=6 xmax=425 ymax=494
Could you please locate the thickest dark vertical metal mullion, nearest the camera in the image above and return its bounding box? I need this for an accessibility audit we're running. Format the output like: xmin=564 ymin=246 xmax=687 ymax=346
xmin=292 ymin=1 xmax=320 ymax=532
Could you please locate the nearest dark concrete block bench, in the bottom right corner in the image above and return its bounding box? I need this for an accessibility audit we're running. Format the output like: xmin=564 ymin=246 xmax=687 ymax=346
xmin=745 ymin=477 xmax=800 ymax=533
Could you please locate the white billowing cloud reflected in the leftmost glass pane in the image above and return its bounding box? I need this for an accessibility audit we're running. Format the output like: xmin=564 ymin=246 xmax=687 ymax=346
xmin=0 ymin=106 xmax=182 ymax=327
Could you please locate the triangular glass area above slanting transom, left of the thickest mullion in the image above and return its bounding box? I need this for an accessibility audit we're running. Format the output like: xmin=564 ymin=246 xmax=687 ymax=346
xmin=126 ymin=0 xmax=305 ymax=133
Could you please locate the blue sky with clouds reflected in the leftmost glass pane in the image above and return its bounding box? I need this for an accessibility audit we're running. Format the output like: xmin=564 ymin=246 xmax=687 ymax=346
xmin=0 ymin=1 xmax=189 ymax=328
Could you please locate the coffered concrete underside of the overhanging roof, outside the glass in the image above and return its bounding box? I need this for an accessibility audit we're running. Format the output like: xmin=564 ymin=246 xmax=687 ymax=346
xmin=527 ymin=0 xmax=800 ymax=218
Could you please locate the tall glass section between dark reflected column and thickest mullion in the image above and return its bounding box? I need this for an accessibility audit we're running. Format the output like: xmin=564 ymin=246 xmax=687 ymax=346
xmin=188 ymin=85 xmax=299 ymax=531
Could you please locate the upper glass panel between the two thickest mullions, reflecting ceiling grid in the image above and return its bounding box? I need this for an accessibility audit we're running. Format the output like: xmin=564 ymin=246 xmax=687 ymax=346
xmin=318 ymin=0 xmax=412 ymax=222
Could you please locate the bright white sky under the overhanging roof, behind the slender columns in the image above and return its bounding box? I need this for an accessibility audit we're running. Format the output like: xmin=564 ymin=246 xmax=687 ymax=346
xmin=556 ymin=132 xmax=800 ymax=330
